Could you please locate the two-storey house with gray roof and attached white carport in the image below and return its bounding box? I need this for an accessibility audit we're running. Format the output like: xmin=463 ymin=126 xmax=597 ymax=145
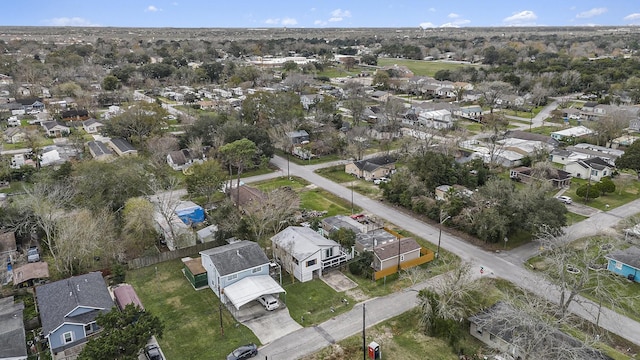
xmin=200 ymin=240 xmax=285 ymax=310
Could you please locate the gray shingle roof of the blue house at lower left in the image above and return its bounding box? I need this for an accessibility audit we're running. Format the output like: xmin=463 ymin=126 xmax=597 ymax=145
xmin=36 ymin=272 xmax=113 ymax=335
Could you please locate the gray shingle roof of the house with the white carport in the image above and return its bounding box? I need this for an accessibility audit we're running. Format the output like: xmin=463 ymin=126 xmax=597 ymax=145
xmin=200 ymin=240 xmax=269 ymax=276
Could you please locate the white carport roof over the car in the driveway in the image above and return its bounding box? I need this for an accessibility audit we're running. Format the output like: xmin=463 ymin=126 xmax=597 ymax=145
xmin=224 ymin=275 xmax=286 ymax=310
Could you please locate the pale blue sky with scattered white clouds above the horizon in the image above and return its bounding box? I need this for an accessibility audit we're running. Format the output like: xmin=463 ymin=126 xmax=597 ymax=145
xmin=0 ymin=0 xmax=640 ymax=28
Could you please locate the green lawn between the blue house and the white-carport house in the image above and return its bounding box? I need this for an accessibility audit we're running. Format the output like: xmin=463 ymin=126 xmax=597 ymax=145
xmin=126 ymin=259 xmax=259 ymax=360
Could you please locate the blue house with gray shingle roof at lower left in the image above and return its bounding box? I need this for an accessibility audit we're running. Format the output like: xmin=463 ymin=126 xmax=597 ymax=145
xmin=36 ymin=272 xmax=114 ymax=359
